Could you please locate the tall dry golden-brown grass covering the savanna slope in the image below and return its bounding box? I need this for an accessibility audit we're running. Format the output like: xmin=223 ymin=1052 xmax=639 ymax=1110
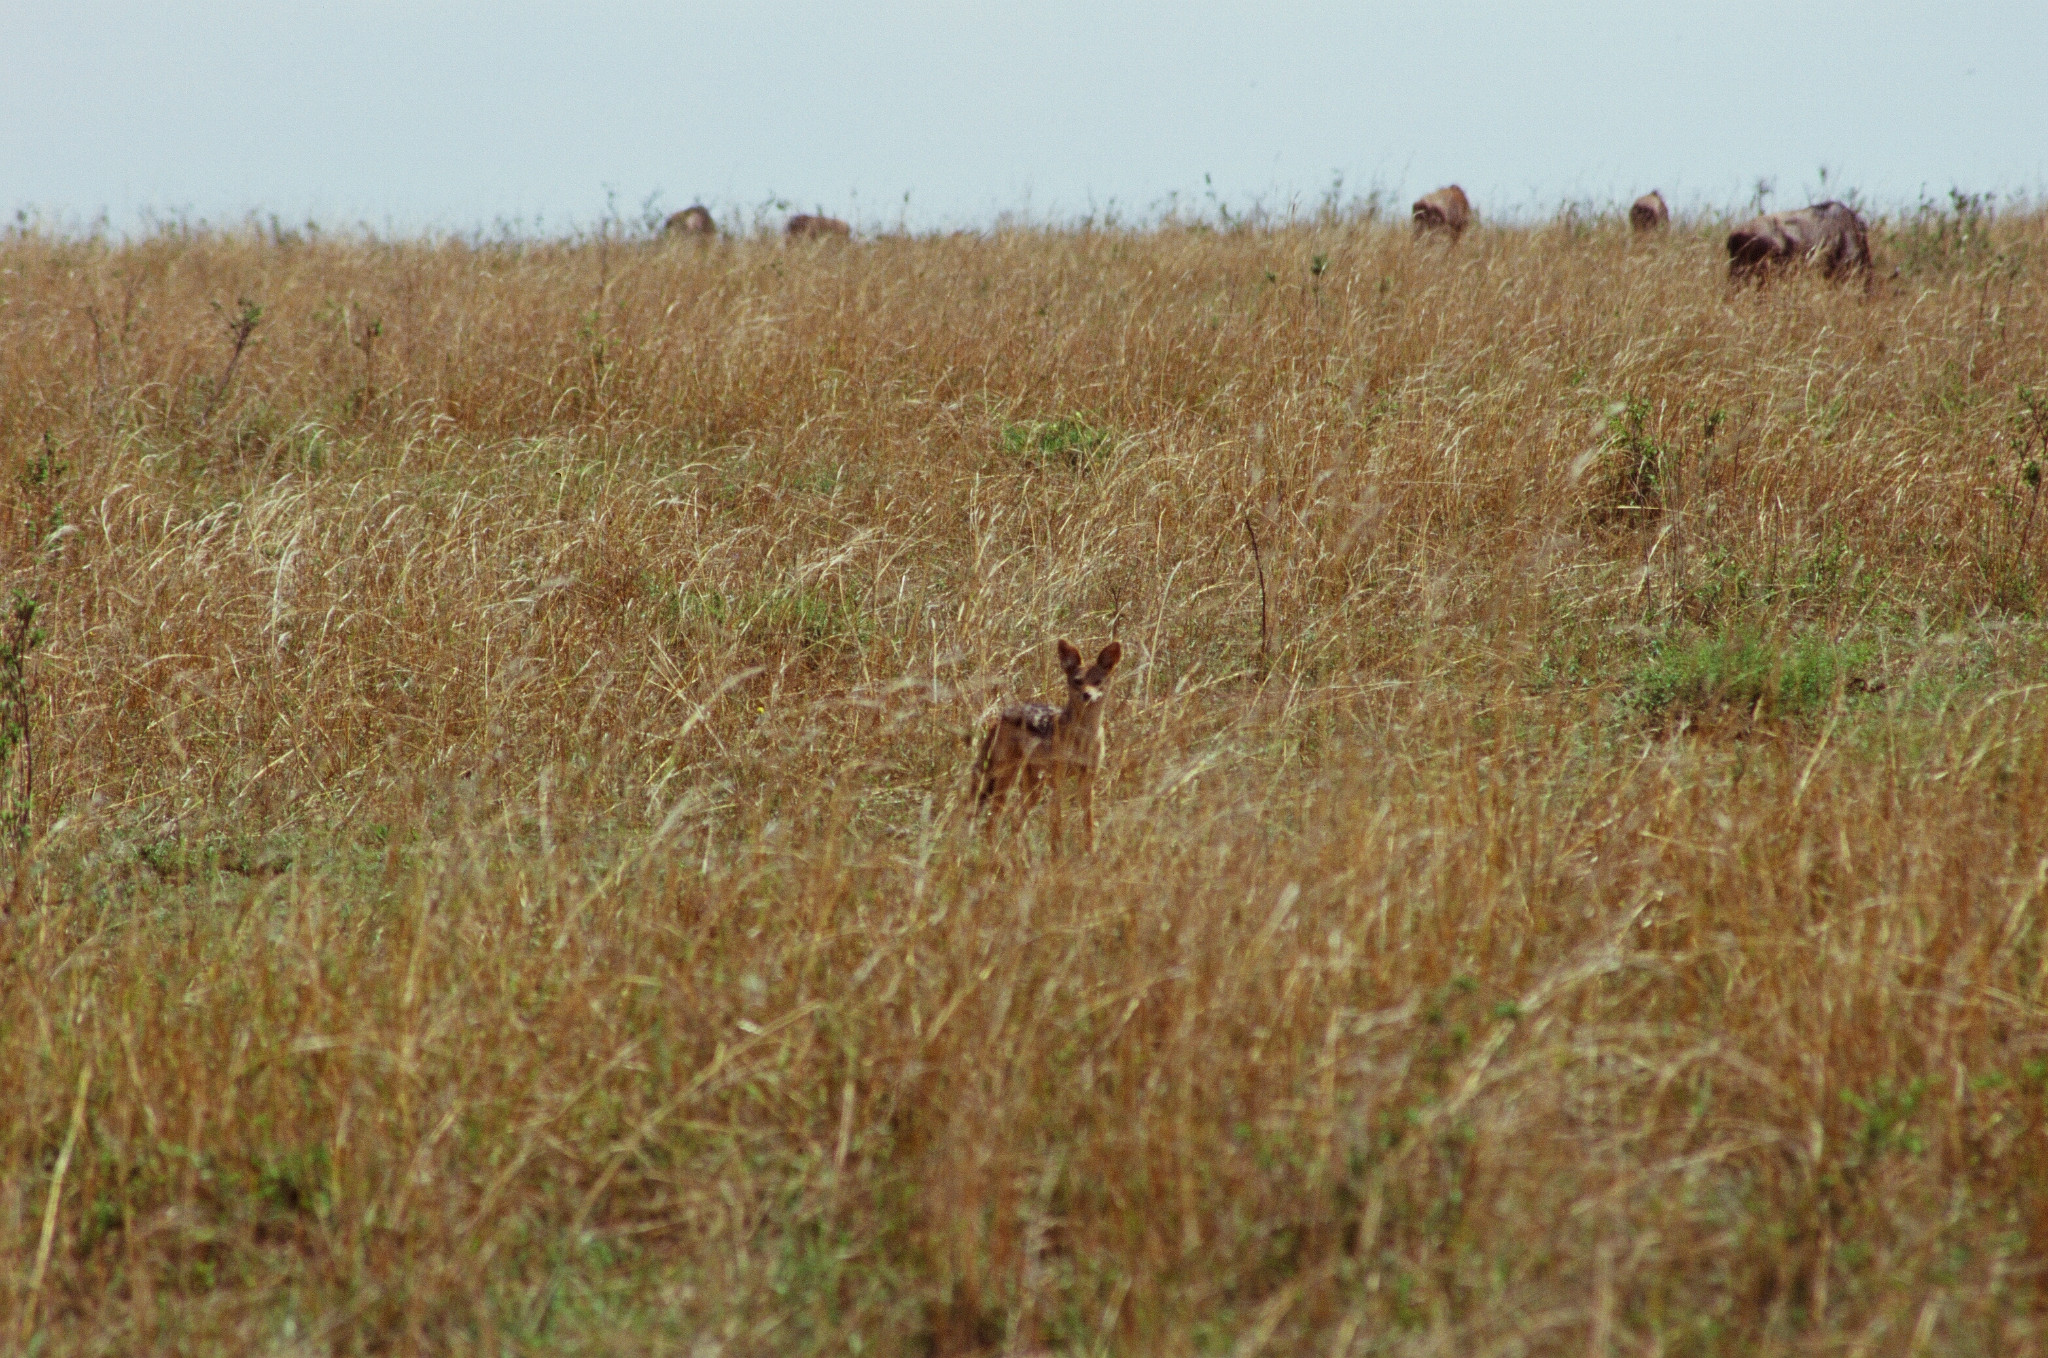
xmin=0 ymin=203 xmax=2048 ymax=1356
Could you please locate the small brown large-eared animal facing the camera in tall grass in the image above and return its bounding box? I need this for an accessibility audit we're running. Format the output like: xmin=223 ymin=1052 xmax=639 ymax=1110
xmin=975 ymin=641 xmax=1124 ymax=852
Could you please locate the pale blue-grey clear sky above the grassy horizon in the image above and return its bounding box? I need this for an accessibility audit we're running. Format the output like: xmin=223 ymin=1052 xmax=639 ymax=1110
xmin=0 ymin=0 xmax=2048 ymax=231
